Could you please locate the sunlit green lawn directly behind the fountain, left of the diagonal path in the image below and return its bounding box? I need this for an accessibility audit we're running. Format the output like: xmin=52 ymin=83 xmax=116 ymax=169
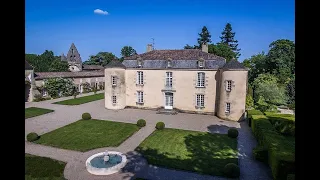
xmin=34 ymin=119 xmax=139 ymax=152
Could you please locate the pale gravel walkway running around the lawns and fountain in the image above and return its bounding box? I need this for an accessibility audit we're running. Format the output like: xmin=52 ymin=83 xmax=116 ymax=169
xmin=25 ymin=94 xmax=272 ymax=180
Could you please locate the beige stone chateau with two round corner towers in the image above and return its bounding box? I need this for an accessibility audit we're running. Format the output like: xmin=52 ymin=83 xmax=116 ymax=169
xmin=104 ymin=45 xmax=248 ymax=121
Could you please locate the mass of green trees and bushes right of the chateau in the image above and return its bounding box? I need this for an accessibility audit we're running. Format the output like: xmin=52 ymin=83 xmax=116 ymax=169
xmin=243 ymin=39 xmax=295 ymax=111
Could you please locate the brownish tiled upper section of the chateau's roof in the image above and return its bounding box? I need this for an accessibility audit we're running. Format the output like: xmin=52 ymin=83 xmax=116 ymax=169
xmin=124 ymin=49 xmax=225 ymax=60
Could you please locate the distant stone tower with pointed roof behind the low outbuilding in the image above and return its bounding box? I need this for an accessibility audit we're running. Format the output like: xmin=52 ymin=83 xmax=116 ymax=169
xmin=66 ymin=43 xmax=82 ymax=72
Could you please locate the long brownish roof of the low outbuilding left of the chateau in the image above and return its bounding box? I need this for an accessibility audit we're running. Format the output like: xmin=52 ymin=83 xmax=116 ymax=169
xmin=34 ymin=71 xmax=104 ymax=80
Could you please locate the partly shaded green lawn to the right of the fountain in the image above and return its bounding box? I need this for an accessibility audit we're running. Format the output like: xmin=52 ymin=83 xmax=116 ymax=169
xmin=136 ymin=129 xmax=238 ymax=176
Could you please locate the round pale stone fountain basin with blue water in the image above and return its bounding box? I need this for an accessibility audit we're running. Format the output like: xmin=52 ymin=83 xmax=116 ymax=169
xmin=86 ymin=151 xmax=127 ymax=175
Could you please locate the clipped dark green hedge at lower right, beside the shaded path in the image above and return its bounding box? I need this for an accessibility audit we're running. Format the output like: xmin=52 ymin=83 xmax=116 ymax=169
xmin=251 ymin=115 xmax=295 ymax=180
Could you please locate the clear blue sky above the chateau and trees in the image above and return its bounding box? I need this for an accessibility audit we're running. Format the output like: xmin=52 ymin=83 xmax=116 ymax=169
xmin=25 ymin=0 xmax=295 ymax=61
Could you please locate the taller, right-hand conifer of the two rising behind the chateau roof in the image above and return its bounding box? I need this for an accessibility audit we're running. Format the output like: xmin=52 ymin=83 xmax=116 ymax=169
xmin=220 ymin=23 xmax=241 ymax=58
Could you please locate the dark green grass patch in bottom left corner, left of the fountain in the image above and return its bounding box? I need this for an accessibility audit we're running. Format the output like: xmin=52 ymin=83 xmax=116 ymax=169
xmin=25 ymin=154 xmax=66 ymax=180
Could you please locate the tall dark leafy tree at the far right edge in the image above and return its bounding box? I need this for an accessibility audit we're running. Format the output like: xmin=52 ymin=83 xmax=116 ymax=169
xmin=265 ymin=39 xmax=295 ymax=84
